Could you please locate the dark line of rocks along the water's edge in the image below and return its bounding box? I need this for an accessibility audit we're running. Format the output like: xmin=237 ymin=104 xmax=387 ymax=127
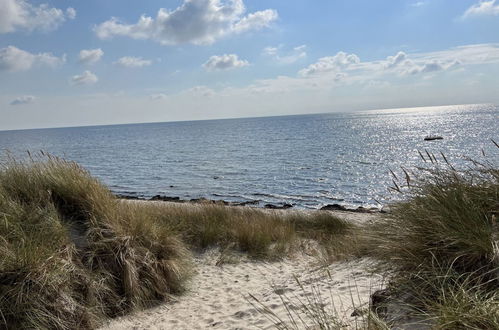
xmin=115 ymin=194 xmax=387 ymax=213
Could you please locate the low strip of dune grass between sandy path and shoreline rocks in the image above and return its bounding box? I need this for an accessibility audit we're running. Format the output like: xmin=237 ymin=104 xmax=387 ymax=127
xmin=121 ymin=201 xmax=356 ymax=260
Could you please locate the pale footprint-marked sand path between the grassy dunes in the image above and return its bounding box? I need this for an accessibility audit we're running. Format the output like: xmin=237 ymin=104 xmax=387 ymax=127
xmin=102 ymin=251 xmax=381 ymax=330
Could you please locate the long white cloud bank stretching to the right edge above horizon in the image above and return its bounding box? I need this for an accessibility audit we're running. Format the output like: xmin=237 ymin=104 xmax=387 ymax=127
xmin=292 ymin=44 xmax=499 ymax=91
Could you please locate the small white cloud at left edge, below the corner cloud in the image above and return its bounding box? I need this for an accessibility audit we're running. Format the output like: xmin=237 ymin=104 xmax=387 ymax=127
xmin=0 ymin=46 xmax=66 ymax=72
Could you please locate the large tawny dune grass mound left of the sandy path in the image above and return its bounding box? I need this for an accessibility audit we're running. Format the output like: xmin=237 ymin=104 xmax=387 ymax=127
xmin=0 ymin=158 xmax=190 ymax=329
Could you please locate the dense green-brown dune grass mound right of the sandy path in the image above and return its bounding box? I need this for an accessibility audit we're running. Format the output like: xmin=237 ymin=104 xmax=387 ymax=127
xmin=370 ymin=157 xmax=499 ymax=329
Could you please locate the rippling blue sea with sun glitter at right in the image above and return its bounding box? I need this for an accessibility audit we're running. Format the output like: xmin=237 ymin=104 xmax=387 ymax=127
xmin=0 ymin=105 xmax=499 ymax=208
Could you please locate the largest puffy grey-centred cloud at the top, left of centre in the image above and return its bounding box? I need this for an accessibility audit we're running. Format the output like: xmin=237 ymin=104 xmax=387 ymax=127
xmin=94 ymin=0 xmax=278 ymax=45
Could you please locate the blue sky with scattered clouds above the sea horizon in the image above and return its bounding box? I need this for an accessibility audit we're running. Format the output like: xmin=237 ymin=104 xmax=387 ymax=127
xmin=0 ymin=0 xmax=499 ymax=130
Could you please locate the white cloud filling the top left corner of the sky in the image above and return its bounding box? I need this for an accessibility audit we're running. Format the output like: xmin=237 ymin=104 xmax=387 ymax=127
xmin=0 ymin=0 xmax=76 ymax=33
